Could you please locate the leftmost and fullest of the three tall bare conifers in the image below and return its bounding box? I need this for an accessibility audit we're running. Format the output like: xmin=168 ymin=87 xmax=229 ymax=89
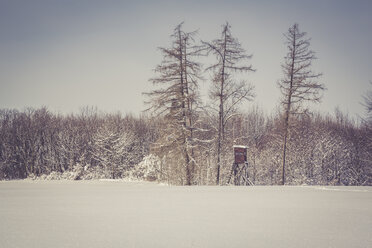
xmin=145 ymin=23 xmax=200 ymax=185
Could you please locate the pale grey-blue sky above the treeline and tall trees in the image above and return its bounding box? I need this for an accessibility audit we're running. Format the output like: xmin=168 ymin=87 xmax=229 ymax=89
xmin=0 ymin=0 xmax=372 ymax=116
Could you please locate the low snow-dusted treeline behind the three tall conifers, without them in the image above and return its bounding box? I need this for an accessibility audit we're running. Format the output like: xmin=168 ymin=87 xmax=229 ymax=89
xmin=0 ymin=105 xmax=372 ymax=185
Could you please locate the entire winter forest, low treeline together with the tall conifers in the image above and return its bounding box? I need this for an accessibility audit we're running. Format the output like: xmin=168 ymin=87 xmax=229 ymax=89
xmin=0 ymin=23 xmax=372 ymax=185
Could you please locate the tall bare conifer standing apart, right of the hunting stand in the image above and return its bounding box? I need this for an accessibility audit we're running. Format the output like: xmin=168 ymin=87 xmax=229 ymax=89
xmin=278 ymin=23 xmax=325 ymax=185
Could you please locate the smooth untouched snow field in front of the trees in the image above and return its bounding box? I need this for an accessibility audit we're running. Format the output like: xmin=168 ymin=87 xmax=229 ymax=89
xmin=0 ymin=181 xmax=372 ymax=248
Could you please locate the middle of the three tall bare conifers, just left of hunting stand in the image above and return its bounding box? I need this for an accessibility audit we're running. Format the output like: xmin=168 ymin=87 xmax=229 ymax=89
xmin=203 ymin=23 xmax=254 ymax=185
